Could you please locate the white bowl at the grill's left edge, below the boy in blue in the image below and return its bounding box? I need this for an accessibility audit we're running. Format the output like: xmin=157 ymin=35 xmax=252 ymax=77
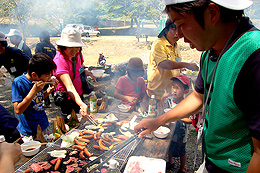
xmin=21 ymin=141 xmax=41 ymax=156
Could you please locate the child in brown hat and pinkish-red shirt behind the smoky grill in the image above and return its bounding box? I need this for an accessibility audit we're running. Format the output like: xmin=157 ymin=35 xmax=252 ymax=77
xmin=114 ymin=58 xmax=148 ymax=111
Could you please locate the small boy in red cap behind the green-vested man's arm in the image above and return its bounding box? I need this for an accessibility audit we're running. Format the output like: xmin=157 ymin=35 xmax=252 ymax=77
xmin=161 ymin=75 xmax=192 ymax=173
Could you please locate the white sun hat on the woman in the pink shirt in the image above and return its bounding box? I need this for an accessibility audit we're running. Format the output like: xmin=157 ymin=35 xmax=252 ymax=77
xmin=56 ymin=27 xmax=85 ymax=47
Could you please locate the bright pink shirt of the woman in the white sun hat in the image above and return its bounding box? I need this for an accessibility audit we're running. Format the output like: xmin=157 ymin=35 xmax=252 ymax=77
xmin=53 ymin=51 xmax=84 ymax=95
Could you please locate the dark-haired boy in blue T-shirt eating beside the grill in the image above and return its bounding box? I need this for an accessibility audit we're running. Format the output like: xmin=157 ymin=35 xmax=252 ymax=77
xmin=11 ymin=53 xmax=58 ymax=136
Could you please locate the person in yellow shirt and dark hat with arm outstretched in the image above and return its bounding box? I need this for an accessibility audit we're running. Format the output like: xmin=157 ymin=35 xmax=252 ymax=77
xmin=147 ymin=19 xmax=199 ymax=100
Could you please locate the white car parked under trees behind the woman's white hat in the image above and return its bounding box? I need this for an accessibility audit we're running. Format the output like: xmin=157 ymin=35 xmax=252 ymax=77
xmin=66 ymin=24 xmax=100 ymax=37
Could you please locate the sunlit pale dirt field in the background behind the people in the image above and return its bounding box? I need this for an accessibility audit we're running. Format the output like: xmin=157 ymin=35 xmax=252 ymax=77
xmin=26 ymin=36 xmax=200 ymax=65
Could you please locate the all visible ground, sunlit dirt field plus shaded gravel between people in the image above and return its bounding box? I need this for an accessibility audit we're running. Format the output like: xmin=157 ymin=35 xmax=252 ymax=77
xmin=0 ymin=36 xmax=202 ymax=173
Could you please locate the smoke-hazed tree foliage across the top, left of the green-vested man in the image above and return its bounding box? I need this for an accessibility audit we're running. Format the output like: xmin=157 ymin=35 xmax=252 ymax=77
xmin=0 ymin=0 xmax=164 ymax=32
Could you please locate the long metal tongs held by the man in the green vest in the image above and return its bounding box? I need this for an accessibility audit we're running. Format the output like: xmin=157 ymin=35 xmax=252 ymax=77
xmin=83 ymin=129 xmax=143 ymax=173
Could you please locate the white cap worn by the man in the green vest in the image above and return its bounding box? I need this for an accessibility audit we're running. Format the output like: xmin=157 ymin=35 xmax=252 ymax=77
xmin=164 ymin=0 xmax=253 ymax=10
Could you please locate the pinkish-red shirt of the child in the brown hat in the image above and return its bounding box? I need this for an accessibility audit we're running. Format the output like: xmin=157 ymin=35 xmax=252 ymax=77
xmin=115 ymin=76 xmax=147 ymax=105
